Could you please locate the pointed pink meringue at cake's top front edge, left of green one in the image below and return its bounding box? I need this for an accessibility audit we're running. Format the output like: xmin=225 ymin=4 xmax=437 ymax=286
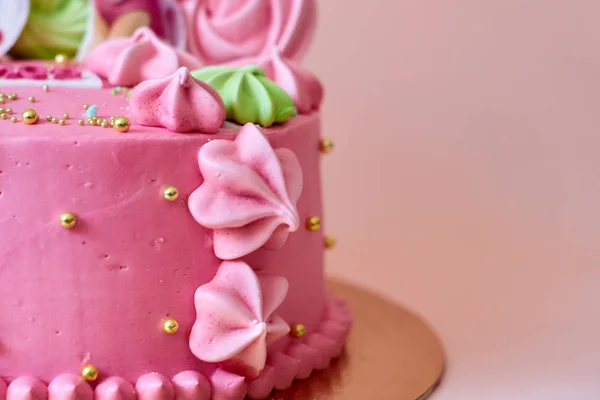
xmin=129 ymin=67 xmax=226 ymax=133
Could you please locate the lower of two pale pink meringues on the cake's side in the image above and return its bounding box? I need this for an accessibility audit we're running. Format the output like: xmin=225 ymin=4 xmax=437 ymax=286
xmin=190 ymin=260 xmax=290 ymax=378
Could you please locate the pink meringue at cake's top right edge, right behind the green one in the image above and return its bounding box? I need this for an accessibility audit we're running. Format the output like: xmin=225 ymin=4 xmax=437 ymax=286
xmin=259 ymin=50 xmax=323 ymax=114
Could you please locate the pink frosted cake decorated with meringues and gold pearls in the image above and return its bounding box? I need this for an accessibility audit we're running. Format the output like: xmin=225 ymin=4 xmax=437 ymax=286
xmin=0 ymin=0 xmax=351 ymax=400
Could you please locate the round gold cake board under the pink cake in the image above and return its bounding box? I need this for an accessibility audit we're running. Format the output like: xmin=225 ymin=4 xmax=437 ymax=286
xmin=269 ymin=281 xmax=444 ymax=400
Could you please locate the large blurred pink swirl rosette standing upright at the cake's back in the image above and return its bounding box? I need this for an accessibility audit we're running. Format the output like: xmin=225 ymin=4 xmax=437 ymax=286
xmin=183 ymin=0 xmax=316 ymax=64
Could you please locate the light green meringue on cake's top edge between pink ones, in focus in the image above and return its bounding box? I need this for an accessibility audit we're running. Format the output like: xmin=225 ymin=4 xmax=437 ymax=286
xmin=191 ymin=65 xmax=296 ymax=127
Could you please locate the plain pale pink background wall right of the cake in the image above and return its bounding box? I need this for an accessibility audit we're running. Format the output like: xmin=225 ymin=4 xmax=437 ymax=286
xmin=307 ymin=0 xmax=600 ymax=400
